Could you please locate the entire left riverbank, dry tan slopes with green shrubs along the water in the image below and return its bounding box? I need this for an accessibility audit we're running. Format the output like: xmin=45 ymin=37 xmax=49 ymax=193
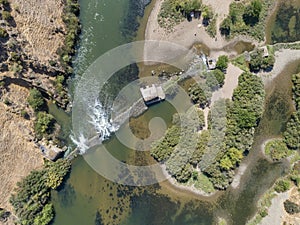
xmin=0 ymin=0 xmax=79 ymax=224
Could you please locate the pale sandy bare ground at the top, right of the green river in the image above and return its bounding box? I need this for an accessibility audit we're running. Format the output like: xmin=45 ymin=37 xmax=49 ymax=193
xmin=144 ymin=0 xmax=257 ymax=59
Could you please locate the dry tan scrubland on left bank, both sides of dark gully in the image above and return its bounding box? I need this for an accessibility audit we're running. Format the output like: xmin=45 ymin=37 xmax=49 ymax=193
xmin=0 ymin=0 xmax=65 ymax=220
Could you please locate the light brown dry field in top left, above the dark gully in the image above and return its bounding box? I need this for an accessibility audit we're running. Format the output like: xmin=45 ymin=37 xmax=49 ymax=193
xmin=10 ymin=0 xmax=64 ymax=64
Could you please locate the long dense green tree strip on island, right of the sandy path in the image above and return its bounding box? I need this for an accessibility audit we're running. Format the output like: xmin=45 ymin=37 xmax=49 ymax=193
xmin=204 ymin=73 xmax=265 ymax=189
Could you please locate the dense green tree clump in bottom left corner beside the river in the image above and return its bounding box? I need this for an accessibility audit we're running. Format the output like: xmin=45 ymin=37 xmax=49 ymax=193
xmin=10 ymin=159 xmax=70 ymax=225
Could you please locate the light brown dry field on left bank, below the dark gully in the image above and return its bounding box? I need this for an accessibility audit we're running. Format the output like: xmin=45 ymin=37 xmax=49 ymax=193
xmin=0 ymin=84 xmax=43 ymax=211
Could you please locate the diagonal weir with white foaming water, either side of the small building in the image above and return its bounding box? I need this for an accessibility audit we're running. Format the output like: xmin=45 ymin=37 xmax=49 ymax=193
xmin=71 ymin=55 xmax=207 ymax=155
